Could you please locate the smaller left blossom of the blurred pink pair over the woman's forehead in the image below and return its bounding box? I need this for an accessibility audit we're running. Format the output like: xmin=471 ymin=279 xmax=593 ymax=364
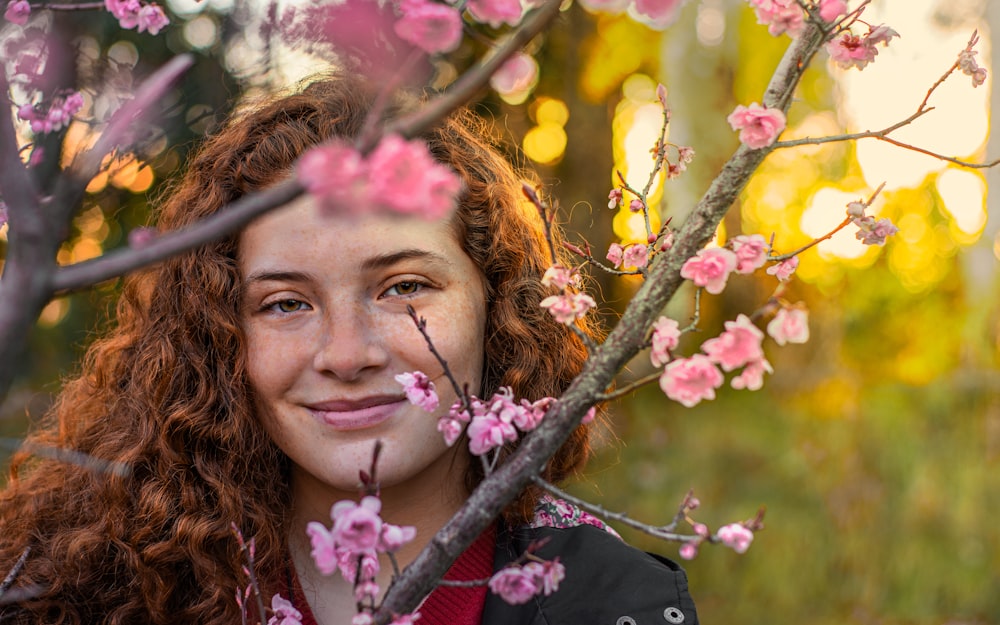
xmin=296 ymin=142 xmax=369 ymax=212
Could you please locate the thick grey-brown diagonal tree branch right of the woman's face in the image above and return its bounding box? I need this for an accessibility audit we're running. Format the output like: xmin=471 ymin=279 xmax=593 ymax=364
xmin=375 ymin=19 xmax=822 ymax=625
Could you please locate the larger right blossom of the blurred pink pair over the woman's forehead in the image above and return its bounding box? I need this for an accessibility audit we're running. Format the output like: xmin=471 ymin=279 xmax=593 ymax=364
xmin=367 ymin=135 xmax=462 ymax=219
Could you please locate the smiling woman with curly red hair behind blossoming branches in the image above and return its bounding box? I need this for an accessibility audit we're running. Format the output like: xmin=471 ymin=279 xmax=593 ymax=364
xmin=0 ymin=78 xmax=697 ymax=625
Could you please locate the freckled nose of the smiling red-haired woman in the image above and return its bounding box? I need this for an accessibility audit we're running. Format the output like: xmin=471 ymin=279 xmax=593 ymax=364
xmin=314 ymin=303 xmax=389 ymax=381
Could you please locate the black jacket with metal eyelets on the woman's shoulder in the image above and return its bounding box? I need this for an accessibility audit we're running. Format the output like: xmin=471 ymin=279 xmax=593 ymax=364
xmin=482 ymin=525 xmax=698 ymax=625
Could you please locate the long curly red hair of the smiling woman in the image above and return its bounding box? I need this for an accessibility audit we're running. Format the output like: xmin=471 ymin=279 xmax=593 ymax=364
xmin=0 ymin=78 xmax=593 ymax=625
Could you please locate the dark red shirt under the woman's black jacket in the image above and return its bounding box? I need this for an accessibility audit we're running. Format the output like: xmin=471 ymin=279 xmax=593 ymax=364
xmin=288 ymin=525 xmax=496 ymax=625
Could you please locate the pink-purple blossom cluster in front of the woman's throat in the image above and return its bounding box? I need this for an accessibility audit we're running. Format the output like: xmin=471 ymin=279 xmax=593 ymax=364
xmin=306 ymin=496 xmax=416 ymax=596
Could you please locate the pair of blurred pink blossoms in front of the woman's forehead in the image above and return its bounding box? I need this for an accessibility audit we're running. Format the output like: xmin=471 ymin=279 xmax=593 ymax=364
xmin=297 ymin=135 xmax=462 ymax=219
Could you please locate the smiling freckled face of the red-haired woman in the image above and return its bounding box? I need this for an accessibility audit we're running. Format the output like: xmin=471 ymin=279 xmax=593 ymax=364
xmin=239 ymin=198 xmax=486 ymax=508
